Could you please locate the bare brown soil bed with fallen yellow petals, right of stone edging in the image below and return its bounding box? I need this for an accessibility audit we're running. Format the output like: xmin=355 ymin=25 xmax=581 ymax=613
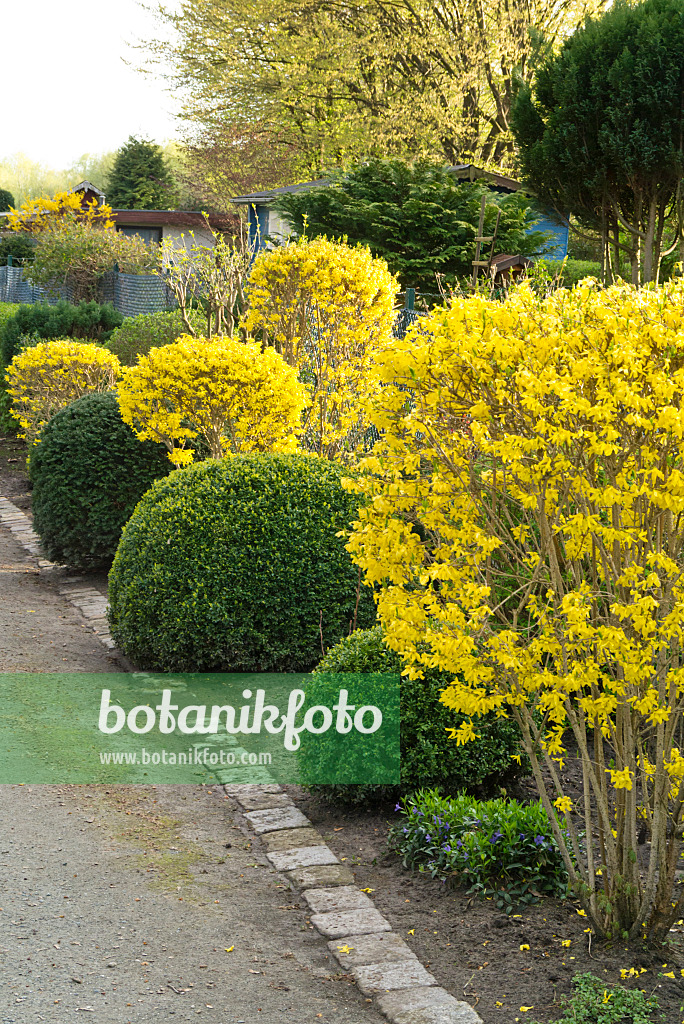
xmin=286 ymin=786 xmax=684 ymax=1024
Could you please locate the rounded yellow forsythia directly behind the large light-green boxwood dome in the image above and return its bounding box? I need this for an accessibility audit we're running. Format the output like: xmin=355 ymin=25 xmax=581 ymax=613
xmin=119 ymin=335 xmax=306 ymax=466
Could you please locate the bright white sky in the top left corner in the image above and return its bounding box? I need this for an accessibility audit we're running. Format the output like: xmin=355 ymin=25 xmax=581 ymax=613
xmin=0 ymin=0 xmax=177 ymax=168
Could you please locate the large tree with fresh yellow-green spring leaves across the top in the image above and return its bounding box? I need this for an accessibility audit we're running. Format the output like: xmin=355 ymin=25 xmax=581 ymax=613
xmin=145 ymin=0 xmax=605 ymax=175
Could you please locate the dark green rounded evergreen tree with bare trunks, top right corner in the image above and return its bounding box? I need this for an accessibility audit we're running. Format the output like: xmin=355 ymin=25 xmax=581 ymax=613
xmin=513 ymin=0 xmax=684 ymax=284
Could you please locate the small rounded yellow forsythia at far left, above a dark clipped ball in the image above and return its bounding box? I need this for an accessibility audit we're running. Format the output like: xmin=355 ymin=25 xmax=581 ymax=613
xmin=5 ymin=339 xmax=119 ymax=441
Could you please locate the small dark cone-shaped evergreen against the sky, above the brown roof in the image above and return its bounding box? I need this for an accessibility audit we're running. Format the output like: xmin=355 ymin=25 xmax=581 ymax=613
xmin=106 ymin=135 xmax=178 ymax=210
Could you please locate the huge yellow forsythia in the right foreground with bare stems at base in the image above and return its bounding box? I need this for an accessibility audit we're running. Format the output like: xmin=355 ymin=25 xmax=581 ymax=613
xmin=347 ymin=282 xmax=684 ymax=941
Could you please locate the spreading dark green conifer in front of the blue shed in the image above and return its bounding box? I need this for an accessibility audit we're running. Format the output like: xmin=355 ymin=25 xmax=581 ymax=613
xmin=275 ymin=160 xmax=545 ymax=292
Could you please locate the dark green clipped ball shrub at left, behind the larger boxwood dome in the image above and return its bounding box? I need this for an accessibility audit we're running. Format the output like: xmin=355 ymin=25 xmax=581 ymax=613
xmin=30 ymin=392 xmax=171 ymax=568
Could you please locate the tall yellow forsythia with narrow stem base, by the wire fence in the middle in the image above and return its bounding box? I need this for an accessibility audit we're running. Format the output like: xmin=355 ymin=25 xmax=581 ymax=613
xmin=243 ymin=238 xmax=398 ymax=459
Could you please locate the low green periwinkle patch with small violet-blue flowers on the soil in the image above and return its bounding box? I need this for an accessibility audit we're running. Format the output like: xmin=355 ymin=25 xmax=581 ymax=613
xmin=388 ymin=790 xmax=567 ymax=912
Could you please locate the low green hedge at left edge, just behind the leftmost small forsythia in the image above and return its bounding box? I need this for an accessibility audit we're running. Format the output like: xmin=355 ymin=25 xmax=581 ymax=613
xmin=0 ymin=300 xmax=123 ymax=366
